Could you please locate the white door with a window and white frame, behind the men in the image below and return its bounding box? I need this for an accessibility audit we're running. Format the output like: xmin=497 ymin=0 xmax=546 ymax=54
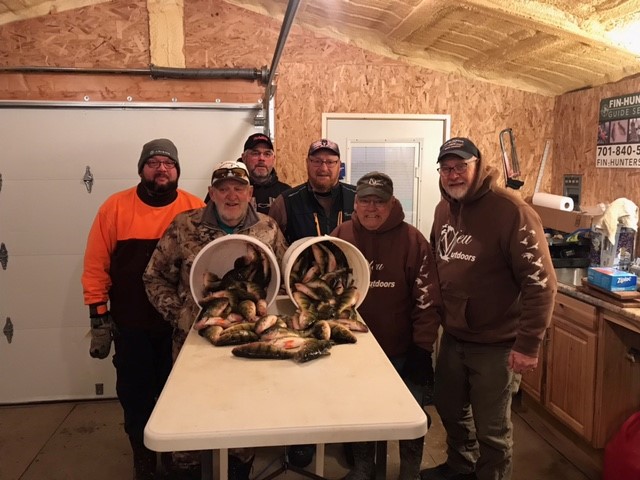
xmin=322 ymin=113 xmax=451 ymax=238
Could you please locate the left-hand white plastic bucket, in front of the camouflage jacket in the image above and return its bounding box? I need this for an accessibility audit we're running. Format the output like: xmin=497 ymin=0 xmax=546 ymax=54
xmin=189 ymin=234 xmax=280 ymax=306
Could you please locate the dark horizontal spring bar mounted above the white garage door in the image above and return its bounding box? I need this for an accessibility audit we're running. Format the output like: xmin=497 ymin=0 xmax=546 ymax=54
xmin=0 ymin=65 xmax=269 ymax=85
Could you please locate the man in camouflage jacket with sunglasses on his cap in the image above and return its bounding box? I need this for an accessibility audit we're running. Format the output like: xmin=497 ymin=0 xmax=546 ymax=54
xmin=143 ymin=161 xmax=287 ymax=480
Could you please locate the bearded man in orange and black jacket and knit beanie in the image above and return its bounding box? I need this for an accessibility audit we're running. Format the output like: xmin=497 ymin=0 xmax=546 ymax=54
xmin=82 ymin=138 xmax=203 ymax=480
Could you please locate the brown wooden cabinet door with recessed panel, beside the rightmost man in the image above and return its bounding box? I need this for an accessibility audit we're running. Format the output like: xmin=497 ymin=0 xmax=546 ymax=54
xmin=546 ymin=313 xmax=597 ymax=440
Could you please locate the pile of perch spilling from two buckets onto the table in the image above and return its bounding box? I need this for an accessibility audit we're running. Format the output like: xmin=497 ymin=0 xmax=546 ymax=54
xmin=194 ymin=242 xmax=368 ymax=362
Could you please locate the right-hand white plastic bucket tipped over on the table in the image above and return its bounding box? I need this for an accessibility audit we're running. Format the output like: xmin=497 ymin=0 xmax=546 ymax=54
xmin=281 ymin=235 xmax=370 ymax=308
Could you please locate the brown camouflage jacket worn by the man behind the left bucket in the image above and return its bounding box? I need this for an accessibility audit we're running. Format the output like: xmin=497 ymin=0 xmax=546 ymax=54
xmin=142 ymin=202 xmax=287 ymax=359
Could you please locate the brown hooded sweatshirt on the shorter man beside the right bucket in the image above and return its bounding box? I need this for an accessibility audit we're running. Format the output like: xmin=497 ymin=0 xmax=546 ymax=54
xmin=331 ymin=197 xmax=441 ymax=357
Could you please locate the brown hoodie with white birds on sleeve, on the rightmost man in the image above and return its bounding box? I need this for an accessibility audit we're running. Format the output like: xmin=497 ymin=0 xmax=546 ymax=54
xmin=431 ymin=160 xmax=557 ymax=357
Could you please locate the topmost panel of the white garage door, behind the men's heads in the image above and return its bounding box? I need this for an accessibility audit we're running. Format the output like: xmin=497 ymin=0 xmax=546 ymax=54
xmin=0 ymin=108 xmax=255 ymax=181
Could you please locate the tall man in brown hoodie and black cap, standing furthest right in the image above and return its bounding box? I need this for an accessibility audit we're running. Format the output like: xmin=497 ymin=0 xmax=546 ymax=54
xmin=421 ymin=137 xmax=557 ymax=480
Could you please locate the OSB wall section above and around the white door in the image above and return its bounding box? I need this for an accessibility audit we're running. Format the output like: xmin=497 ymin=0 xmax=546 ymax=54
xmin=276 ymin=61 xmax=553 ymax=190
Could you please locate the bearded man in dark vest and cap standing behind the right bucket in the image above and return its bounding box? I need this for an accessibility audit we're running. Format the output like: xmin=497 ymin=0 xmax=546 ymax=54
xmin=269 ymin=139 xmax=355 ymax=244
